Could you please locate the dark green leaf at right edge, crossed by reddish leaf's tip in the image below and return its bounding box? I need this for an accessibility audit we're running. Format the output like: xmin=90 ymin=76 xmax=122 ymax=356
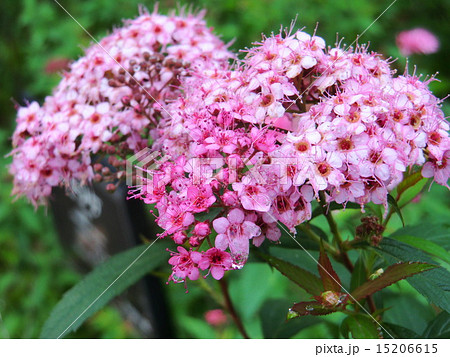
xmin=375 ymin=238 xmax=450 ymax=312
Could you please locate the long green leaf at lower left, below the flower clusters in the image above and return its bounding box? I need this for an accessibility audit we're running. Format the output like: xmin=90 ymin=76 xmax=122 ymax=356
xmin=40 ymin=242 xmax=168 ymax=338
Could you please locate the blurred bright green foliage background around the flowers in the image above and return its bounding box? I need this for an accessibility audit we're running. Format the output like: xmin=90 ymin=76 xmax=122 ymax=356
xmin=0 ymin=0 xmax=450 ymax=338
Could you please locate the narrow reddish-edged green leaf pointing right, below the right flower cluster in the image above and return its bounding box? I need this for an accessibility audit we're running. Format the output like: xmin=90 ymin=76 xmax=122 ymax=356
xmin=351 ymin=262 xmax=436 ymax=300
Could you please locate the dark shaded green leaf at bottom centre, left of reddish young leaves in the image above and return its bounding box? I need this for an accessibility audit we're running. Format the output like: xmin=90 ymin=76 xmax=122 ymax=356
xmin=259 ymin=299 xmax=321 ymax=338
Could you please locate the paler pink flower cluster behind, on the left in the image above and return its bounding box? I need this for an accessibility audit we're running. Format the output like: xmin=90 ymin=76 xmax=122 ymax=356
xmin=10 ymin=8 xmax=233 ymax=204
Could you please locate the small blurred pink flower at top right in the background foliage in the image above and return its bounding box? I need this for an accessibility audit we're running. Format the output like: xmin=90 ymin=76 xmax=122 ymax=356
xmin=395 ymin=28 xmax=439 ymax=56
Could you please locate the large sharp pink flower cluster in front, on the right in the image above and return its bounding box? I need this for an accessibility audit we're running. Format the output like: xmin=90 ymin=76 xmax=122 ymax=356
xmin=136 ymin=27 xmax=450 ymax=281
